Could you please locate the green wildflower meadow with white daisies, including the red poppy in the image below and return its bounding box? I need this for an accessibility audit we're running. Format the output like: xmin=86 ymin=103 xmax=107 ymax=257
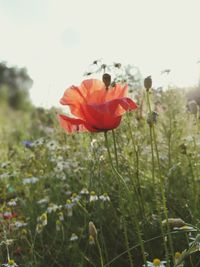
xmin=0 ymin=74 xmax=200 ymax=267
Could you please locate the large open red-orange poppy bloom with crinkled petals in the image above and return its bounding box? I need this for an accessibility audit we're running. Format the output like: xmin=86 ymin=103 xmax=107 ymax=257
xmin=58 ymin=79 xmax=137 ymax=133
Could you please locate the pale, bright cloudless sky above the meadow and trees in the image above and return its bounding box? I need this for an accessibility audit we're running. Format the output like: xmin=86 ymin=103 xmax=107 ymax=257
xmin=0 ymin=0 xmax=200 ymax=107
